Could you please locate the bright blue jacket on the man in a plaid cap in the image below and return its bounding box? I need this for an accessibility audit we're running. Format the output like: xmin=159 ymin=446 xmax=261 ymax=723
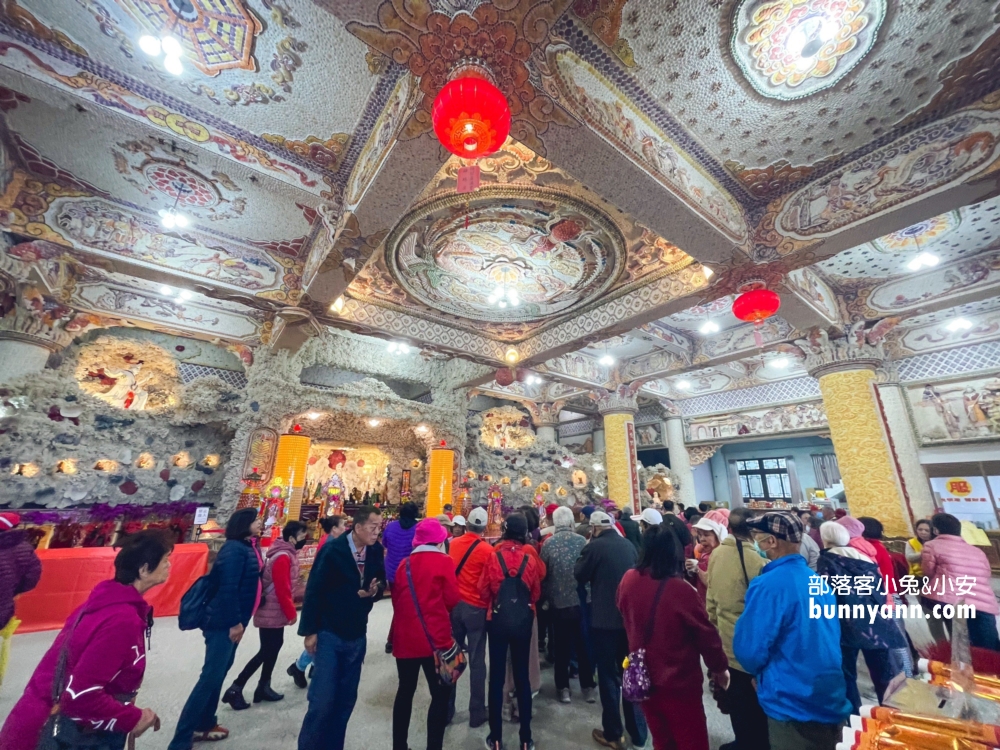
xmin=733 ymin=555 xmax=851 ymax=724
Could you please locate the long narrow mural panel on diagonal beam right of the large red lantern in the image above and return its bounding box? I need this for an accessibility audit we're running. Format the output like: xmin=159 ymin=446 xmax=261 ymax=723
xmin=549 ymin=48 xmax=747 ymax=242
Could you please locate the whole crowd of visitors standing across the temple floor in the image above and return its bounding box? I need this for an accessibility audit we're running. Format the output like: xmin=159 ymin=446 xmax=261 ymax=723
xmin=0 ymin=502 xmax=1000 ymax=750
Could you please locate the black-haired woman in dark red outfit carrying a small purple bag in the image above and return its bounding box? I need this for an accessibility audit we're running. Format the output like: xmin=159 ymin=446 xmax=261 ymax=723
xmin=618 ymin=526 xmax=729 ymax=750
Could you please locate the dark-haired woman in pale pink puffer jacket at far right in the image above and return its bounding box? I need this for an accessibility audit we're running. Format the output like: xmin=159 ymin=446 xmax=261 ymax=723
xmin=920 ymin=513 xmax=1000 ymax=651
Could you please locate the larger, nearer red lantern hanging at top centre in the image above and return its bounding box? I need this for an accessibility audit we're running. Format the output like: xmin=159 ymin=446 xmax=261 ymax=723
xmin=431 ymin=75 xmax=510 ymax=159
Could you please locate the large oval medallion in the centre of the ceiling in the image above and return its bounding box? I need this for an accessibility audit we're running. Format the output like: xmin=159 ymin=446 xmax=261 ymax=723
xmin=386 ymin=188 xmax=625 ymax=322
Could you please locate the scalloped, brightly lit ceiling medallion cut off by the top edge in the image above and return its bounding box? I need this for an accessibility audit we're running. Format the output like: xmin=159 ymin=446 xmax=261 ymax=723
xmin=730 ymin=0 xmax=886 ymax=100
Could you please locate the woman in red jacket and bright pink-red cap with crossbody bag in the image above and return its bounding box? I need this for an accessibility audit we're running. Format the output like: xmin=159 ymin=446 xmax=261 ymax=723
xmin=392 ymin=518 xmax=459 ymax=750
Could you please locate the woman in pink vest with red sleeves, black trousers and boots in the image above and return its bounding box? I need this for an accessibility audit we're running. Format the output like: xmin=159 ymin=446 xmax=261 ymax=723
xmin=222 ymin=521 xmax=308 ymax=711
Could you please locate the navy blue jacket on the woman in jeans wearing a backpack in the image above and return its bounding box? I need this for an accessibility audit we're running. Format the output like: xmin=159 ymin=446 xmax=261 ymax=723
xmin=202 ymin=539 xmax=260 ymax=630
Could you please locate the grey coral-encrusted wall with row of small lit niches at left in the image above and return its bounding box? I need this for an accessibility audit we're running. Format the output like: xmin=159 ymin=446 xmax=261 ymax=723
xmin=0 ymin=329 xmax=241 ymax=508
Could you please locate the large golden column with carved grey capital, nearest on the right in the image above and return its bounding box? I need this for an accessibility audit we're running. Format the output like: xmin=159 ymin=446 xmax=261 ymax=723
xmin=799 ymin=334 xmax=913 ymax=536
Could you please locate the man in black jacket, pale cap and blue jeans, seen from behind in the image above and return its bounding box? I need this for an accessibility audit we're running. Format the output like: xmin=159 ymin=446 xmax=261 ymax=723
xmin=573 ymin=510 xmax=647 ymax=750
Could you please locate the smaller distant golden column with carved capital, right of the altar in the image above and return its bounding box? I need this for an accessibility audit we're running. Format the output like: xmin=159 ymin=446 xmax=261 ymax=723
xmin=595 ymin=385 xmax=641 ymax=513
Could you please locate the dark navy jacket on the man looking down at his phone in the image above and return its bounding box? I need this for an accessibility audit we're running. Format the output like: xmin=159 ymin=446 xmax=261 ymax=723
xmin=299 ymin=532 xmax=385 ymax=641
